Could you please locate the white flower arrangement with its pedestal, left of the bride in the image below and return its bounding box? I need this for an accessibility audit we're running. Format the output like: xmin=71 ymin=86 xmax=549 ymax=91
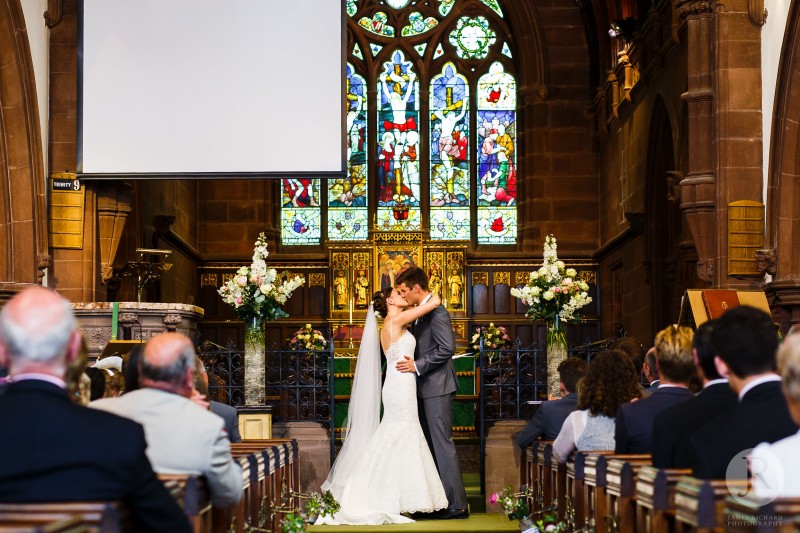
xmin=219 ymin=232 xmax=305 ymax=405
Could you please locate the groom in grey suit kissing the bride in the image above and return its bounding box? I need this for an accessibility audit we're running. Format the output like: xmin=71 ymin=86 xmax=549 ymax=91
xmin=395 ymin=267 xmax=469 ymax=518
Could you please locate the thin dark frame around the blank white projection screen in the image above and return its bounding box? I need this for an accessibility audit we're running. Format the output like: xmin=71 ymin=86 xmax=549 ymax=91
xmin=76 ymin=0 xmax=348 ymax=181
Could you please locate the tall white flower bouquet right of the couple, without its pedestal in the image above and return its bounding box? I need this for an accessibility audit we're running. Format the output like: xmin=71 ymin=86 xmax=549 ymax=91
xmin=511 ymin=235 xmax=592 ymax=322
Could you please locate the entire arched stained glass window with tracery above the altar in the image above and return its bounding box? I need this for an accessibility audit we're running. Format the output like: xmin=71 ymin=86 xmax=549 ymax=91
xmin=281 ymin=0 xmax=518 ymax=245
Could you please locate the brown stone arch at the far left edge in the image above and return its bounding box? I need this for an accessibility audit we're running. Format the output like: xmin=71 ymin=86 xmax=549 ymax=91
xmin=0 ymin=0 xmax=48 ymax=290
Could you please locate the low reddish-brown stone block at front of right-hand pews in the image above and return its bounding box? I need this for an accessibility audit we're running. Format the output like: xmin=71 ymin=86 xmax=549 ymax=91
xmin=485 ymin=420 xmax=528 ymax=513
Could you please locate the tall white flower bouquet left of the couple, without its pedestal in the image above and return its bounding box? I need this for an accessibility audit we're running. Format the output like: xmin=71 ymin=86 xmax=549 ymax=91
xmin=219 ymin=232 xmax=305 ymax=321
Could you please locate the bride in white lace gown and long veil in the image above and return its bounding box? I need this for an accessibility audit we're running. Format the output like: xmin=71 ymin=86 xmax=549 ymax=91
xmin=316 ymin=288 xmax=447 ymax=525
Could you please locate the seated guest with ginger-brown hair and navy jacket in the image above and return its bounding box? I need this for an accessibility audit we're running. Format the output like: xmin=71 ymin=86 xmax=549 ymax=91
xmin=614 ymin=326 xmax=695 ymax=453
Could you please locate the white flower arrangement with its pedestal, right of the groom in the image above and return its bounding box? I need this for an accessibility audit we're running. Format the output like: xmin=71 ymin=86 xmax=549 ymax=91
xmin=511 ymin=235 xmax=592 ymax=397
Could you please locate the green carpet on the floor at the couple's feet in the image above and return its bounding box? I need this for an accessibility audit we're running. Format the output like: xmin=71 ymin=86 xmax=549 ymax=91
xmin=308 ymin=474 xmax=519 ymax=533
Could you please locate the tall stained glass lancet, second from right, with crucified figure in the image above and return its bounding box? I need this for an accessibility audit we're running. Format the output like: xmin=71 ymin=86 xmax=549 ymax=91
xmin=429 ymin=63 xmax=470 ymax=240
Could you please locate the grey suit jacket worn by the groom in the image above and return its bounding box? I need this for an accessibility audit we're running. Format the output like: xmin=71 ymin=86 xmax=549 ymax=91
xmin=412 ymin=305 xmax=458 ymax=398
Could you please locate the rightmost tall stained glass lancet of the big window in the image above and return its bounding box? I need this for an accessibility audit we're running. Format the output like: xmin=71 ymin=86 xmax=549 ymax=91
xmin=476 ymin=63 xmax=517 ymax=244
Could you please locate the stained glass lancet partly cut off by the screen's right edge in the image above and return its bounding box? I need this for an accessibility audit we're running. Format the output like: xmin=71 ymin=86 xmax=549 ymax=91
xmin=328 ymin=64 xmax=369 ymax=241
